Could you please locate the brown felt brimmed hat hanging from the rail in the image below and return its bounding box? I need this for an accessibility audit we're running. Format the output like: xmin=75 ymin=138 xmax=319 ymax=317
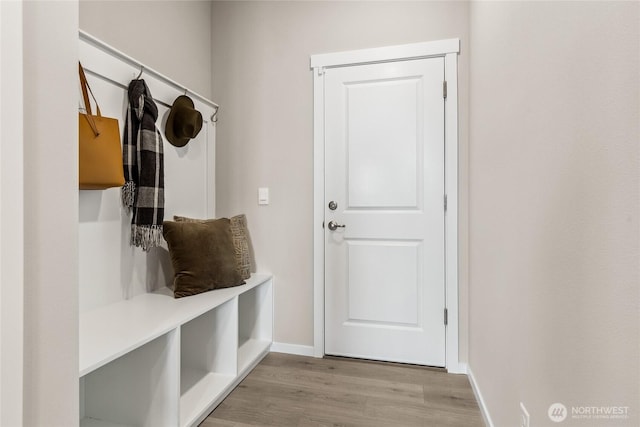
xmin=164 ymin=95 xmax=202 ymax=147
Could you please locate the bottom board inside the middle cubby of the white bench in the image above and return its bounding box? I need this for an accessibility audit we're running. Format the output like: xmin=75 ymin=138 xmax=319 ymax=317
xmin=180 ymin=369 xmax=236 ymax=426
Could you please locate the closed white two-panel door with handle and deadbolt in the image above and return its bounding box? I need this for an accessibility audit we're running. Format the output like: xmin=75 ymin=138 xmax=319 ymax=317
xmin=325 ymin=58 xmax=445 ymax=366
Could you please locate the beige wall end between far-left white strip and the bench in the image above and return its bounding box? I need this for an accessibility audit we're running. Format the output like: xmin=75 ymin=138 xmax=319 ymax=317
xmin=21 ymin=1 xmax=78 ymax=427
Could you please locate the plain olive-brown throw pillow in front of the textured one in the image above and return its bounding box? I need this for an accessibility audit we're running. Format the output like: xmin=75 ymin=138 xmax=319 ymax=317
xmin=163 ymin=218 xmax=244 ymax=298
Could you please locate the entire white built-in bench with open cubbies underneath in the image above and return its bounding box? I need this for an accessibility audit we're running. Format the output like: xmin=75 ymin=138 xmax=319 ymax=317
xmin=79 ymin=274 xmax=273 ymax=427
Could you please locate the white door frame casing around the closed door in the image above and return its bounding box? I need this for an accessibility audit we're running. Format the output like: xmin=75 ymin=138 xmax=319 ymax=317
xmin=310 ymin=39 xmax=465 ymax=373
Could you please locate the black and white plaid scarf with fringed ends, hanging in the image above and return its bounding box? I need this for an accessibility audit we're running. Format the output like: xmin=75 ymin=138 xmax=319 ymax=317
xmin=122 ymin=80 xmax=164 ymax=251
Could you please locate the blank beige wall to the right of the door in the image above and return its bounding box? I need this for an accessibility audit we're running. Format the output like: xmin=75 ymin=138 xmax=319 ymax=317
xmin=469 ymin=2 xmax=640 ymax=427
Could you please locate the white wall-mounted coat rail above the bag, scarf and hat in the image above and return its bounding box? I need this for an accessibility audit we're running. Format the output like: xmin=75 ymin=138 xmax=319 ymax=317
xmin=79 ymin=30 xmax=220 ymax=123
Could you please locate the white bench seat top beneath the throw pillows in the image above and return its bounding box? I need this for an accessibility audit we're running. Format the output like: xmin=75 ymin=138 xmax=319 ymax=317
xmin=79 ymin=274 xmax=271 ymax=377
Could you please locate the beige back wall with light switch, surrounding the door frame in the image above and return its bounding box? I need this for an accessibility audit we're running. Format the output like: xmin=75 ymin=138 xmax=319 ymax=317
xmin=212 ymin=1 xmax=469 ymax=358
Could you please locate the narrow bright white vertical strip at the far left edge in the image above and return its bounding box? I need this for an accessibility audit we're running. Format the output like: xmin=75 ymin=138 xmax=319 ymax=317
xmin=0 ymin=2 xmax=24 ymax=426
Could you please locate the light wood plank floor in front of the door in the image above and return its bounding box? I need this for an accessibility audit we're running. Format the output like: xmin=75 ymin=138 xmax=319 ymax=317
xmin=201 ymin=353 xmax=484 ymax=427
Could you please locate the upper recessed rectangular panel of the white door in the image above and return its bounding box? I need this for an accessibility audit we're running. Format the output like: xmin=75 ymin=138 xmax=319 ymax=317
xmin=345 ymin=77 xmax=420 ymax=208
